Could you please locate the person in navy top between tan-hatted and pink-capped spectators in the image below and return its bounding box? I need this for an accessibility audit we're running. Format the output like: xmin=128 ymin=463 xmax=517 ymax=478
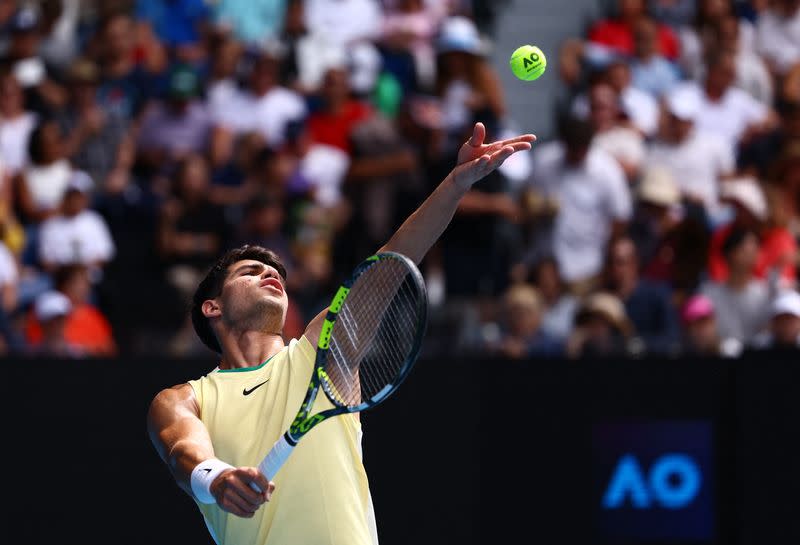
xmin=606 ymin=237 xmax=680 ymax=355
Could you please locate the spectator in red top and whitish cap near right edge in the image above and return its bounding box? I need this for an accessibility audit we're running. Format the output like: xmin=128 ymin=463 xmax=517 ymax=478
xmin=708 ymin=177 xmax=798 ymax=287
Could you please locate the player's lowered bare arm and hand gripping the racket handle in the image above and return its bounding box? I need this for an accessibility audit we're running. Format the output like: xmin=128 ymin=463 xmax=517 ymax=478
xmin=147 ymin=384 xmax=268 ymax=518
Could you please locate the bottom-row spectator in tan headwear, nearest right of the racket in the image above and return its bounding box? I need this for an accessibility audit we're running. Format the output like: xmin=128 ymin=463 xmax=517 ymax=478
xmin=487 ymin=284 xmax=564 ymax=360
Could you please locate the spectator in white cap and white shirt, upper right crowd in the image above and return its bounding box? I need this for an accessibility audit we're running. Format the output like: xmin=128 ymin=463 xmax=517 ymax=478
xmin=645 ymin=85 xmax=735 ymax=222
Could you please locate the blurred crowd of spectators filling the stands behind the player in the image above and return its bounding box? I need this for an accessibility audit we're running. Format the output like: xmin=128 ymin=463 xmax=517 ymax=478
xmin=0 ymin=0 xmax=800 ymax=359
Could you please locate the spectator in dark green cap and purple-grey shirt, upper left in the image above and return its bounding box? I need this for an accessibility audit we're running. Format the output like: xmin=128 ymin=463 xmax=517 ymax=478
xmin=137 ymin=64 xmax=211 ymax=173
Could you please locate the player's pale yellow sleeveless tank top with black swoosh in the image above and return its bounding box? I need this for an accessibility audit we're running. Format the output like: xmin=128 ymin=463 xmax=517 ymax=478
xmin=189 ymin=336 xmax=378 ymax=545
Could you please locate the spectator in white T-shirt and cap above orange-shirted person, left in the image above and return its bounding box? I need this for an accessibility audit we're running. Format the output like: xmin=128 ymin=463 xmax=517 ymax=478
xmin=39 ymin=170 xmax=116 ymax=274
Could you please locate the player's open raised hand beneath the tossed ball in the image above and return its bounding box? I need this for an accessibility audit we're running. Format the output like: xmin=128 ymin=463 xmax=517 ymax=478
xmin=453 ymin=123 xmax=536 ymax=189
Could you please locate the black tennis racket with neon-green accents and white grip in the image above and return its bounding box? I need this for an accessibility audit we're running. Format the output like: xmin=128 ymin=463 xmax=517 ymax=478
xmin=258 ymin=252 xmax=428 ymax=479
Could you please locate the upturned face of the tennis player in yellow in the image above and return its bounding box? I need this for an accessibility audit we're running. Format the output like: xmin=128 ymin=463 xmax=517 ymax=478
xmin=219 ymin=259 xmax=289 ymax=332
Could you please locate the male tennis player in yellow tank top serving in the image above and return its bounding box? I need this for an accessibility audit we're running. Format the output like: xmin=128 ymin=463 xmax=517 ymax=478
xmin=147 ymin=123 xmax=535 ymax=545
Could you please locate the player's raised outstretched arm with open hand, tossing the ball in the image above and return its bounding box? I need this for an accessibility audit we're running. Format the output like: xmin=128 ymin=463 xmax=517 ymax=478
xmin=305 ymin=123 xmax=536 ymax=346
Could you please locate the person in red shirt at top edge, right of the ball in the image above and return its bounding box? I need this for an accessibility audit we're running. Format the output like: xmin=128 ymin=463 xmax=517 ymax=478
xmin=588 ymin=0 xmax=680 ymax=61
